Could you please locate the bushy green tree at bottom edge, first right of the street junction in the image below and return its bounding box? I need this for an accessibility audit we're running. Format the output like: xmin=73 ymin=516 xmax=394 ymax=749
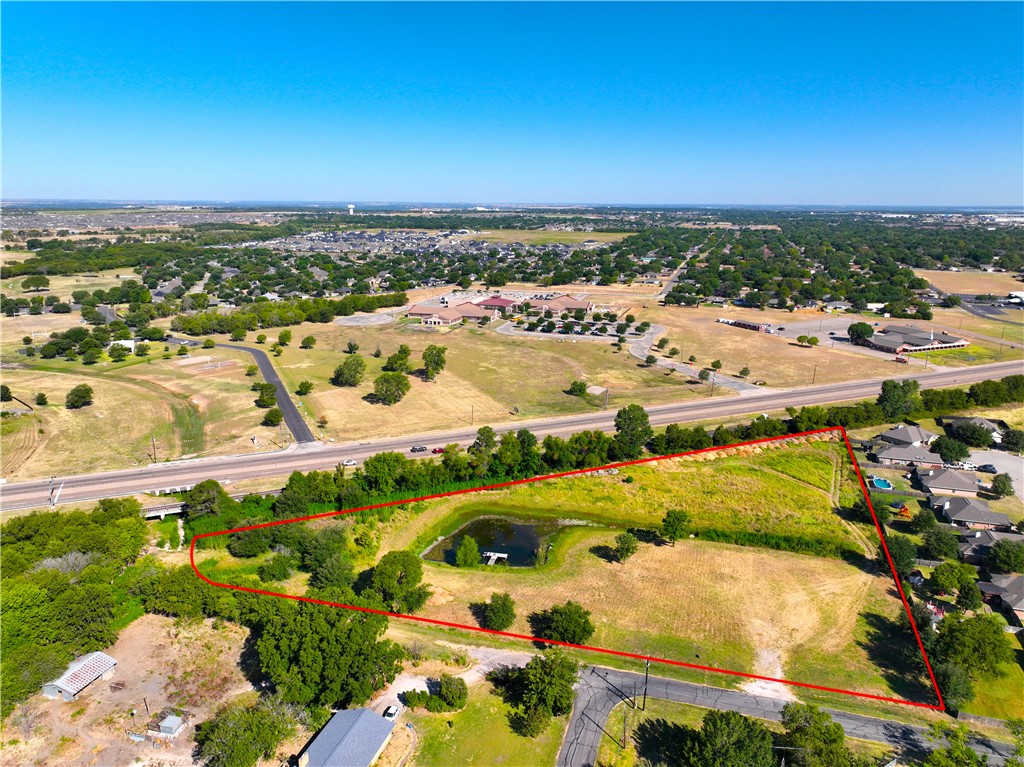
xmin=682 ymin=711 xmax=776 ymax=767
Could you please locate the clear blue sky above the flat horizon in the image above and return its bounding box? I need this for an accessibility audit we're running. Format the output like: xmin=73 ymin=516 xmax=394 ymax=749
xmin=2 ymin=2 xmax=1024 ymax=205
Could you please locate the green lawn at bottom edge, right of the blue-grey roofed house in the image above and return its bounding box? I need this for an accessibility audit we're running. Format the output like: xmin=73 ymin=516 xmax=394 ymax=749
xmin=402 ymin=684 xmax=568 ymax=767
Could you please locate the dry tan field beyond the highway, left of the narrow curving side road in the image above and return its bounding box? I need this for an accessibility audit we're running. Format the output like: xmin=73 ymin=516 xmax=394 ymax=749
xmin=0 ymin=349 xmax=284 ymax=480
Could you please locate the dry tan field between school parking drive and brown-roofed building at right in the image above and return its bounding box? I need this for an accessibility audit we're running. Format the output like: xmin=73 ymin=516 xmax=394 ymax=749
xmin=639 ymin=306 xmax=893 ymax=388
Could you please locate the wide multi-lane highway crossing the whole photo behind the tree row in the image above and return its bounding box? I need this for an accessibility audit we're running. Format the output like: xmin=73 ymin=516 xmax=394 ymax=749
xmin=0 ymin=360 xmax=1024 ymax=511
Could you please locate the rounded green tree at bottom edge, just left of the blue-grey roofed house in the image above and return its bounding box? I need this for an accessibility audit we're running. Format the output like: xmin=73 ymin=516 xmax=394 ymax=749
xmin=196 ymin=697 xmax=297 ymax=767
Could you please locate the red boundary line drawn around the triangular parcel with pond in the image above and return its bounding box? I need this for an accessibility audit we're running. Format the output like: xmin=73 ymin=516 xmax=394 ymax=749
xmin=188 ymin=426 xmax=946 ymax=711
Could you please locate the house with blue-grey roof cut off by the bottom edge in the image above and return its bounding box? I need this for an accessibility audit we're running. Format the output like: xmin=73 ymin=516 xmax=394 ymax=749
xmin=298 ymin=709 xmax=394 ymax=767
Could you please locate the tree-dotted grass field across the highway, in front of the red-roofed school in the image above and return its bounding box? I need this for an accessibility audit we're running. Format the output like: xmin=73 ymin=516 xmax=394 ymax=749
xmin=239 ymin=322 xmax=702 ymax=440
